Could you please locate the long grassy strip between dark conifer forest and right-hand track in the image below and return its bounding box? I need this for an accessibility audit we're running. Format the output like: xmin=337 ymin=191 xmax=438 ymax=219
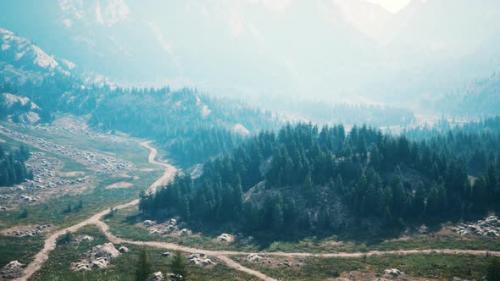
xmin=106 ymin=203 xmax=500 ymax=253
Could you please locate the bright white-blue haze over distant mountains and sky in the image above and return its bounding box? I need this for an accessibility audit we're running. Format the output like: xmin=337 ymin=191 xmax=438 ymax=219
xmin=0 ymin=0 xmax=500 ymax=109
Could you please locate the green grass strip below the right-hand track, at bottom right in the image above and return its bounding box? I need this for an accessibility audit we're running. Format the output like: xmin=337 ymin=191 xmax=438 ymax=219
xmin=238 ymin=255 xmax=492 ymax=281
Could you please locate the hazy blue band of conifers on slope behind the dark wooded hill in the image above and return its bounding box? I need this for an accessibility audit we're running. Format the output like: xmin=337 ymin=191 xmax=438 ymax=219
xmin=0 ymin=78 xmax=278 ymax=167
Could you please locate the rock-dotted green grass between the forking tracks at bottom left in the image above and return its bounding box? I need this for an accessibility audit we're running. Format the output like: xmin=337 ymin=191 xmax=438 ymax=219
xmin=30 ymin=227 xmax=257 ymax=281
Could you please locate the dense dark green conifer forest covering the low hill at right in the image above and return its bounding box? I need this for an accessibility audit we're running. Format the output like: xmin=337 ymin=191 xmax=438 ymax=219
xmin=140 ymin=120 xmax=500 ymax=237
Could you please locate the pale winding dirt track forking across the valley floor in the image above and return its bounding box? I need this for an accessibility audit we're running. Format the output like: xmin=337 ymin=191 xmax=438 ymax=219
xmin=15 ymin=142 xmax=500 ymax=281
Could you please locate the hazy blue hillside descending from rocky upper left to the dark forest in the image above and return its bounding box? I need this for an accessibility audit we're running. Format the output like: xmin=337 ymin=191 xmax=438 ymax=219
xmin=0 ymin=29 xmax=278 ymax=166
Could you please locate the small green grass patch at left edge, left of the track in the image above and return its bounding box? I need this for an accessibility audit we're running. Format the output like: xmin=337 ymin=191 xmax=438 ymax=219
xmin=0 ymin=236 xmax=43 ymax=267
